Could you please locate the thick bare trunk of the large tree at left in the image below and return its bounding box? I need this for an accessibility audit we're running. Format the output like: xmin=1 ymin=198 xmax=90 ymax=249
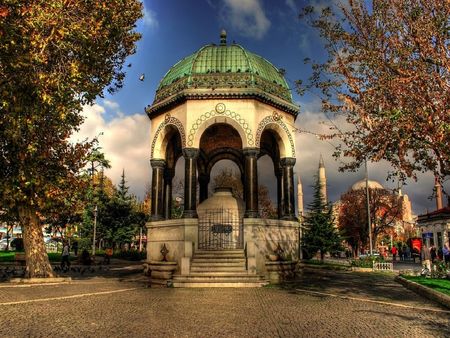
xmin=19 ymin=206 xmax=55 ymax=278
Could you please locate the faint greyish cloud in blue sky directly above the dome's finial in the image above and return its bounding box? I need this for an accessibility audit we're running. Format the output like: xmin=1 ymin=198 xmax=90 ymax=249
xmin=224 ymin=0 xmax=271 ymax=39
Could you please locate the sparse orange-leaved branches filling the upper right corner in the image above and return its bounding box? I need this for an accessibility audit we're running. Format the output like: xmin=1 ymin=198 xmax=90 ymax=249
xmin=297 ymin=0 xmax=450 ymax=179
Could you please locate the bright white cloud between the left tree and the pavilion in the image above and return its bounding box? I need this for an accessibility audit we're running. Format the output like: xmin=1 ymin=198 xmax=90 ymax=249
xmin=72 ymin=100 xmax=150 ymax=198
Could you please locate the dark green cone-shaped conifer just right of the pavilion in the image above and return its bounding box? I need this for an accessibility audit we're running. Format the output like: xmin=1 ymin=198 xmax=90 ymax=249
xmin=302 ymin=176 xmax=341 ymax=261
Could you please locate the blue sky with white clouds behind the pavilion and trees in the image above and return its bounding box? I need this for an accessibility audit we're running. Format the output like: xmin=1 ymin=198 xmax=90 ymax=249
xmin=76 ymin=0 xmax=450 ymax=213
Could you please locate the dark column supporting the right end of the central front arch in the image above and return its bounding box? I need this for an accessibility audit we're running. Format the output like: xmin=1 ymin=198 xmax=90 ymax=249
xmin=243 ymin=148 xmax=259 ymax=218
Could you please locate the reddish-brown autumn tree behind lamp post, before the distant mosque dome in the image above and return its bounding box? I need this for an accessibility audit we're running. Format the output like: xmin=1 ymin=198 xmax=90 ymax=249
xmin=338 ymin=188 xmax=403 ymax=254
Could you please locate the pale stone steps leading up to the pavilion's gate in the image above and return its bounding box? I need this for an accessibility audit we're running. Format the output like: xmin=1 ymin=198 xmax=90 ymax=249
xmin=173 ymin=250 xmax=268 ymax=288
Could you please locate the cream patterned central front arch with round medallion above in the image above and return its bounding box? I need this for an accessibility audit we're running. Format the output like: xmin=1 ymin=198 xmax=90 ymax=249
xmin=187 ymin=103 xmax=254 ymax=147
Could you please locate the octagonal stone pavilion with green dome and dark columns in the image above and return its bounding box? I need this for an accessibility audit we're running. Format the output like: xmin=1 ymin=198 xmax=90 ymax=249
xmin=146 ymin=31 xmax=299 ymax=282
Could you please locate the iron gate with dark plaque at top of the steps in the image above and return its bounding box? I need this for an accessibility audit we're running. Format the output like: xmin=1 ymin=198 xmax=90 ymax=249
xmin=198 ymin=209 xmax=243 ymax=250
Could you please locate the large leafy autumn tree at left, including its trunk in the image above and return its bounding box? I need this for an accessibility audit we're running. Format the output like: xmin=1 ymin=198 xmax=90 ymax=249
xmin=0 ymin=0 xmax=142 ymax=277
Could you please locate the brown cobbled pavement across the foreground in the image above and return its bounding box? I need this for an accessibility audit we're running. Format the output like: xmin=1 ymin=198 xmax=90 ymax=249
xmin=0 ymin=271 xmax=450 ymax=337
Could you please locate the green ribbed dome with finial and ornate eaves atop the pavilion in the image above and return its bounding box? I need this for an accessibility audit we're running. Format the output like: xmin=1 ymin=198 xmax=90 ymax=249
xmin=148 ymin=30 xmax=299 ymax=115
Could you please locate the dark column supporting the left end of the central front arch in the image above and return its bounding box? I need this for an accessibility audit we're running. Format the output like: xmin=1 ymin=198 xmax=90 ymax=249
xmin=183 ymin=148 xmax=199 ymax=218
